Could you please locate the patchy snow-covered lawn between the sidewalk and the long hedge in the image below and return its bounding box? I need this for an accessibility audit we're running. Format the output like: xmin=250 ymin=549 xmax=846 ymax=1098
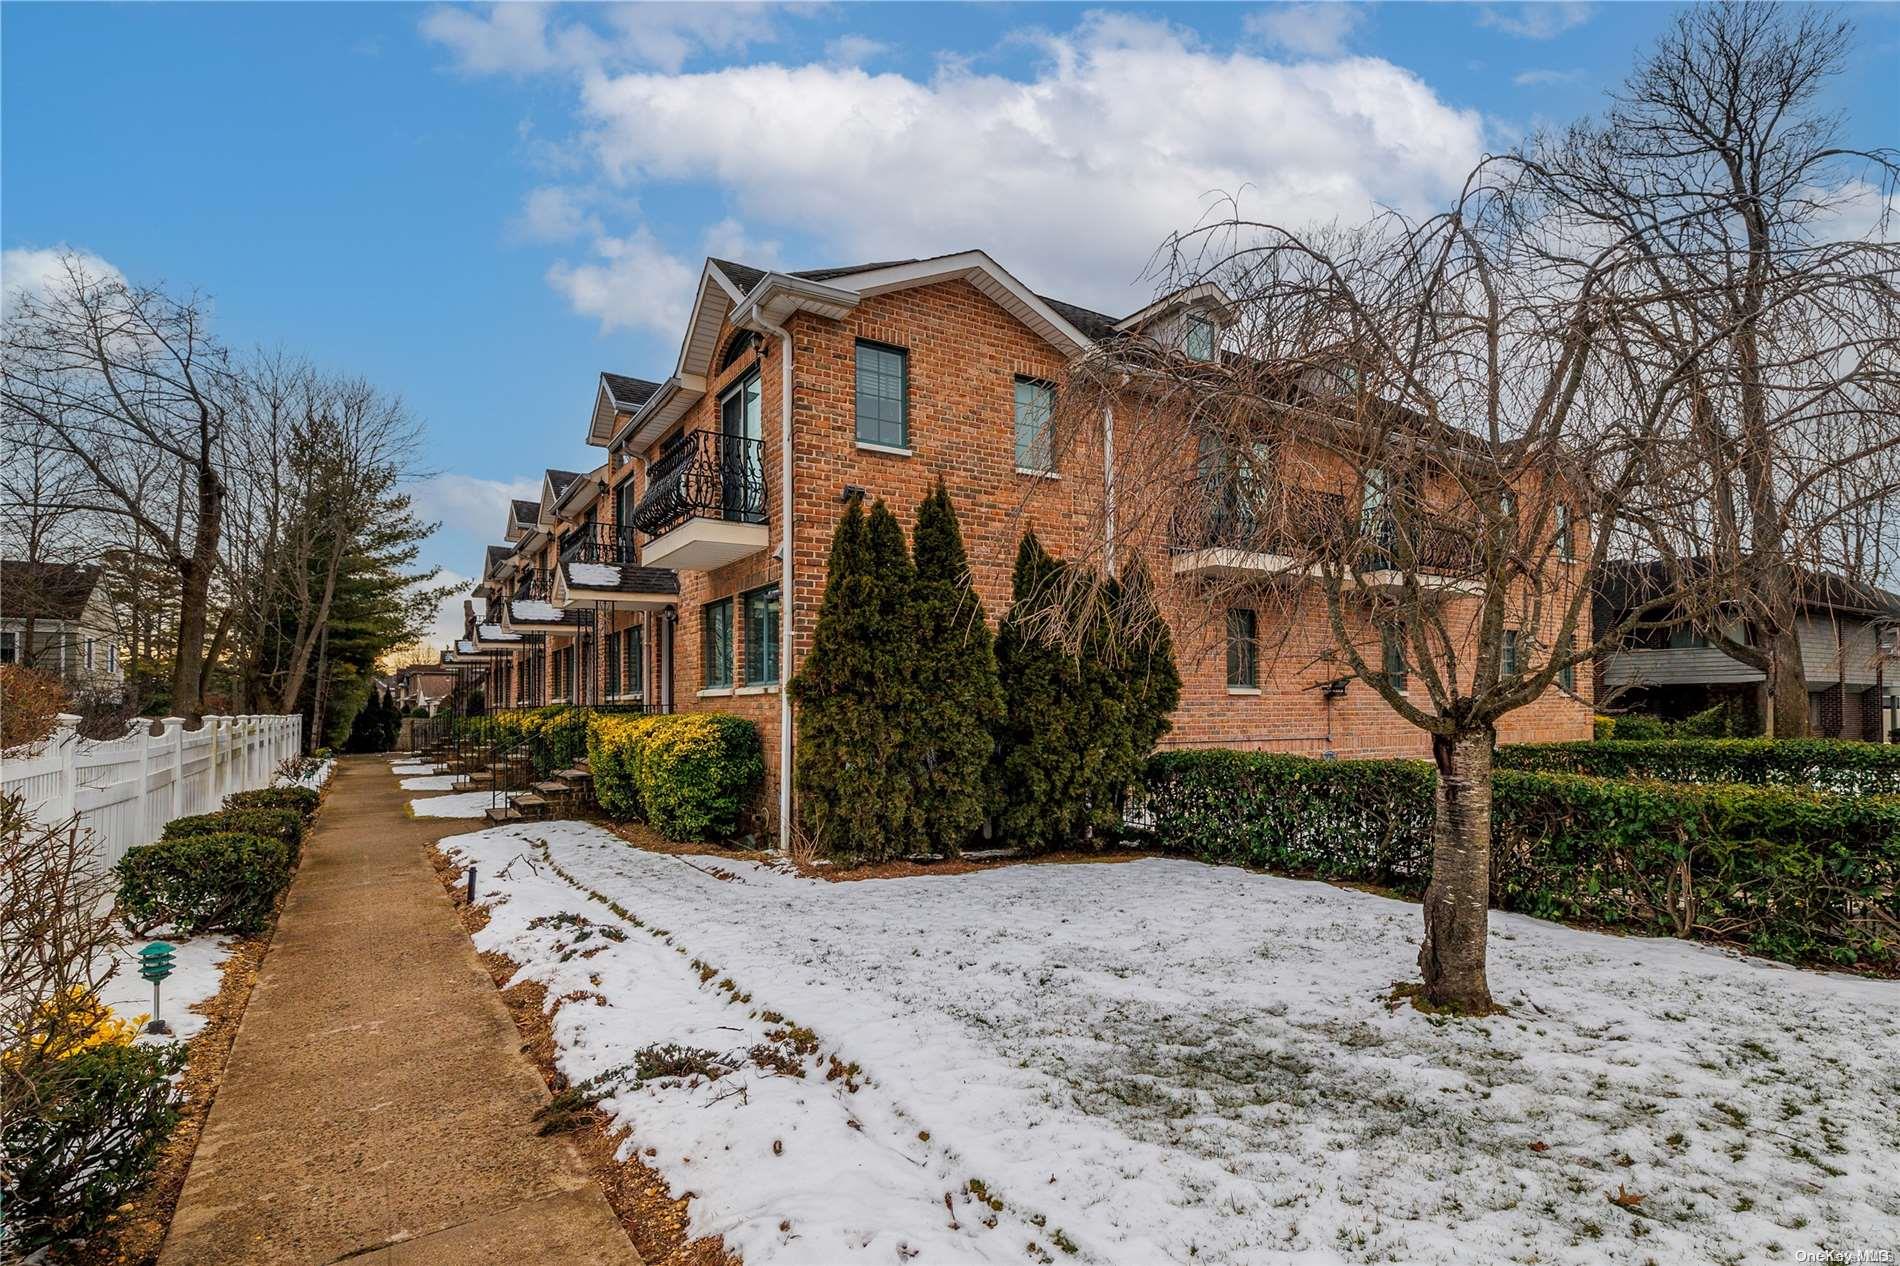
xmin=443 ymin=823 xmax=1900 ymax=1266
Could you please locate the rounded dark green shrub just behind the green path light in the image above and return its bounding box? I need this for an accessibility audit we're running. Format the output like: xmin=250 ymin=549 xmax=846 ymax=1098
xmin=116 ymin=831 xmax=291 ymax=935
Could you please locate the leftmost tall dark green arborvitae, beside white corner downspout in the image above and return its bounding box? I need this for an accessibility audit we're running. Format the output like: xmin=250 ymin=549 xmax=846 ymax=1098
xmin=792 ymin=500 xmax=923 ymax=861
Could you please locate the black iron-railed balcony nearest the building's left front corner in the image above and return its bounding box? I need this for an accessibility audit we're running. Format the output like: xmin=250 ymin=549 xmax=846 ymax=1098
xmin=633 ymin=432 xmax=770 ymax=572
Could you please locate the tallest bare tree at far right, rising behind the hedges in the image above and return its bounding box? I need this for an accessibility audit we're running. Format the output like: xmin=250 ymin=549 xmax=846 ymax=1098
xmin=1522 ymin=0 xmax=1900 ymax=736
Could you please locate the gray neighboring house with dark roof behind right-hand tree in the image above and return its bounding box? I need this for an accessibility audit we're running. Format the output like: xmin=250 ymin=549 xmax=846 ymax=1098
xmin=1594 ymin=563 xmax=1900 ymax=741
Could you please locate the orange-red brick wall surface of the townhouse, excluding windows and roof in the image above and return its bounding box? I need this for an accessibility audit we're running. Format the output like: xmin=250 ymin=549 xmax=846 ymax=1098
xmin=602 ymin=273 xmax=1592 ymax=802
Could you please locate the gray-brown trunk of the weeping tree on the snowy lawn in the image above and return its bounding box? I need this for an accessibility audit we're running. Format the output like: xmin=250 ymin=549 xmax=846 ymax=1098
xmin=1419 ymin=726 xmax=1497 ymax=1013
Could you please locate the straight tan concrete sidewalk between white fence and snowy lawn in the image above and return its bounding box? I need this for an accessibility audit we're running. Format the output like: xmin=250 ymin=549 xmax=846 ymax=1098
xmin=160 ymin=757 xmax=640 ymax=1266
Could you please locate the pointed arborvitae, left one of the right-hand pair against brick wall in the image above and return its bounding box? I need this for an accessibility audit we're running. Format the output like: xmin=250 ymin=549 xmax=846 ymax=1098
xmin=996 ymin=532 xmax=1091 ymax=850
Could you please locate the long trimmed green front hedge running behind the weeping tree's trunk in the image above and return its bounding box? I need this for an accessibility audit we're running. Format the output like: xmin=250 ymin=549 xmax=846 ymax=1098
xmin=1148 ymin=751 xmax=1900 ymax=969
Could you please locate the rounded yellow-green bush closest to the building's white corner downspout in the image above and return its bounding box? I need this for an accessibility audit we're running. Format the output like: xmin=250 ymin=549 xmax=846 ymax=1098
xmin=587 ymin=713 xmax=766 ymax=840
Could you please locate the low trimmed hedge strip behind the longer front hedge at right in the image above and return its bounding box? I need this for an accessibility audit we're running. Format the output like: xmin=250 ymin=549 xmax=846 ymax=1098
xmin=1497 ymin=733 xmax=1900 ymax=796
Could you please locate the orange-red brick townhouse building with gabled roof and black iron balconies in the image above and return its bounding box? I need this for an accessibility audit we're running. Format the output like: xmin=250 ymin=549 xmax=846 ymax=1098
xmin=454 ymin=251 xmax=1590 ymax=836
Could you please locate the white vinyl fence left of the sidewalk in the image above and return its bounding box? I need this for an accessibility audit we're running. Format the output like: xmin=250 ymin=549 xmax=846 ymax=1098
xmin=0 ymin=717 xmax=304 ymax=865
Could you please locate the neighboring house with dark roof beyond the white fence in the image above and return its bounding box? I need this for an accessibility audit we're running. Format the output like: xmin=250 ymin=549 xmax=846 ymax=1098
xmin=0 ymin=559 xmax=125 ymax=690
